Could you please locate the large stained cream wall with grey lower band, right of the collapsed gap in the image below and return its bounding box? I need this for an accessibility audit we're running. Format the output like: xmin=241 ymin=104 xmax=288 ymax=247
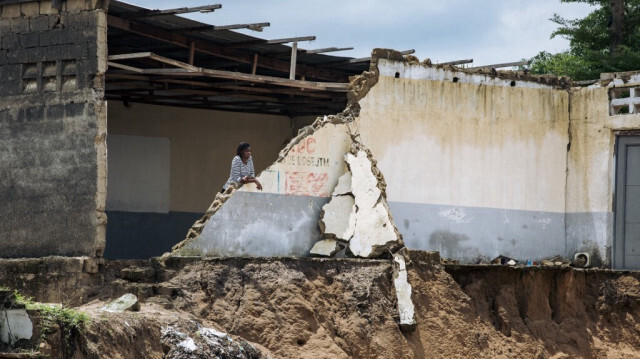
xmin=357 ymin=59 xmax=569 ymax=261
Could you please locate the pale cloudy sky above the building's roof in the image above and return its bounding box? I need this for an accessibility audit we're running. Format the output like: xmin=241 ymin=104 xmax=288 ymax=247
xmin=121 ymin=0 xmax=593 ymax=66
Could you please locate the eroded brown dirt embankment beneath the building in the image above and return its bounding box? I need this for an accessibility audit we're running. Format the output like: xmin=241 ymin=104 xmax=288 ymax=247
xmin=3 ymin=252 xmax=640 ymax=359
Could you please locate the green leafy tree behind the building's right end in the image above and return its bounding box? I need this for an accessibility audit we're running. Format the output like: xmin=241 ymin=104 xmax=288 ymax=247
xmin=529 ymin=0 xmax=640 ymax=80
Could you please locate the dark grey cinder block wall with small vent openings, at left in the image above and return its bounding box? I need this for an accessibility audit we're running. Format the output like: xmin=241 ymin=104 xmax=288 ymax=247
xmin=0 ymin=0 xmax=107 ymax=257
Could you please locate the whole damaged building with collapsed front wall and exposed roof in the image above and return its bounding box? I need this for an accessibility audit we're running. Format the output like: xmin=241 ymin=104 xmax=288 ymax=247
xmin=0 ymin=0 xmax=640 ymax=269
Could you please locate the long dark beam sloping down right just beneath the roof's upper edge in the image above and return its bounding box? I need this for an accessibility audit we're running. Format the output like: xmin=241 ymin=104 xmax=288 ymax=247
xmin=107 ymin=15 xmax=348 ymax=82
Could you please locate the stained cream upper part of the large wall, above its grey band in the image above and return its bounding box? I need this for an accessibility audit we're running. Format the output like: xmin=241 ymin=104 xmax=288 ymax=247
xmin=358 ymin=60 xmax=569 ymax=212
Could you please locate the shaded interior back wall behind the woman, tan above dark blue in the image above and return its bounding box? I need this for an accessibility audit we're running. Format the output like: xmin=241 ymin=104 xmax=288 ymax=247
xmin=105 ymin=101 xmax=308 ymax=258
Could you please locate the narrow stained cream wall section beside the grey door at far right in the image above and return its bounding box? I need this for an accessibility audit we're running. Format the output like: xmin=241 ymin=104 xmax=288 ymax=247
xmin=566 ymin=84 xmax=640 ymax=264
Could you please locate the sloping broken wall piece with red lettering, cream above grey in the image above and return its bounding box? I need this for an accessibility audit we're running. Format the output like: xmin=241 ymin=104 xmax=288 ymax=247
xmin=179 ymin=122 xmax=351 ymax=257
